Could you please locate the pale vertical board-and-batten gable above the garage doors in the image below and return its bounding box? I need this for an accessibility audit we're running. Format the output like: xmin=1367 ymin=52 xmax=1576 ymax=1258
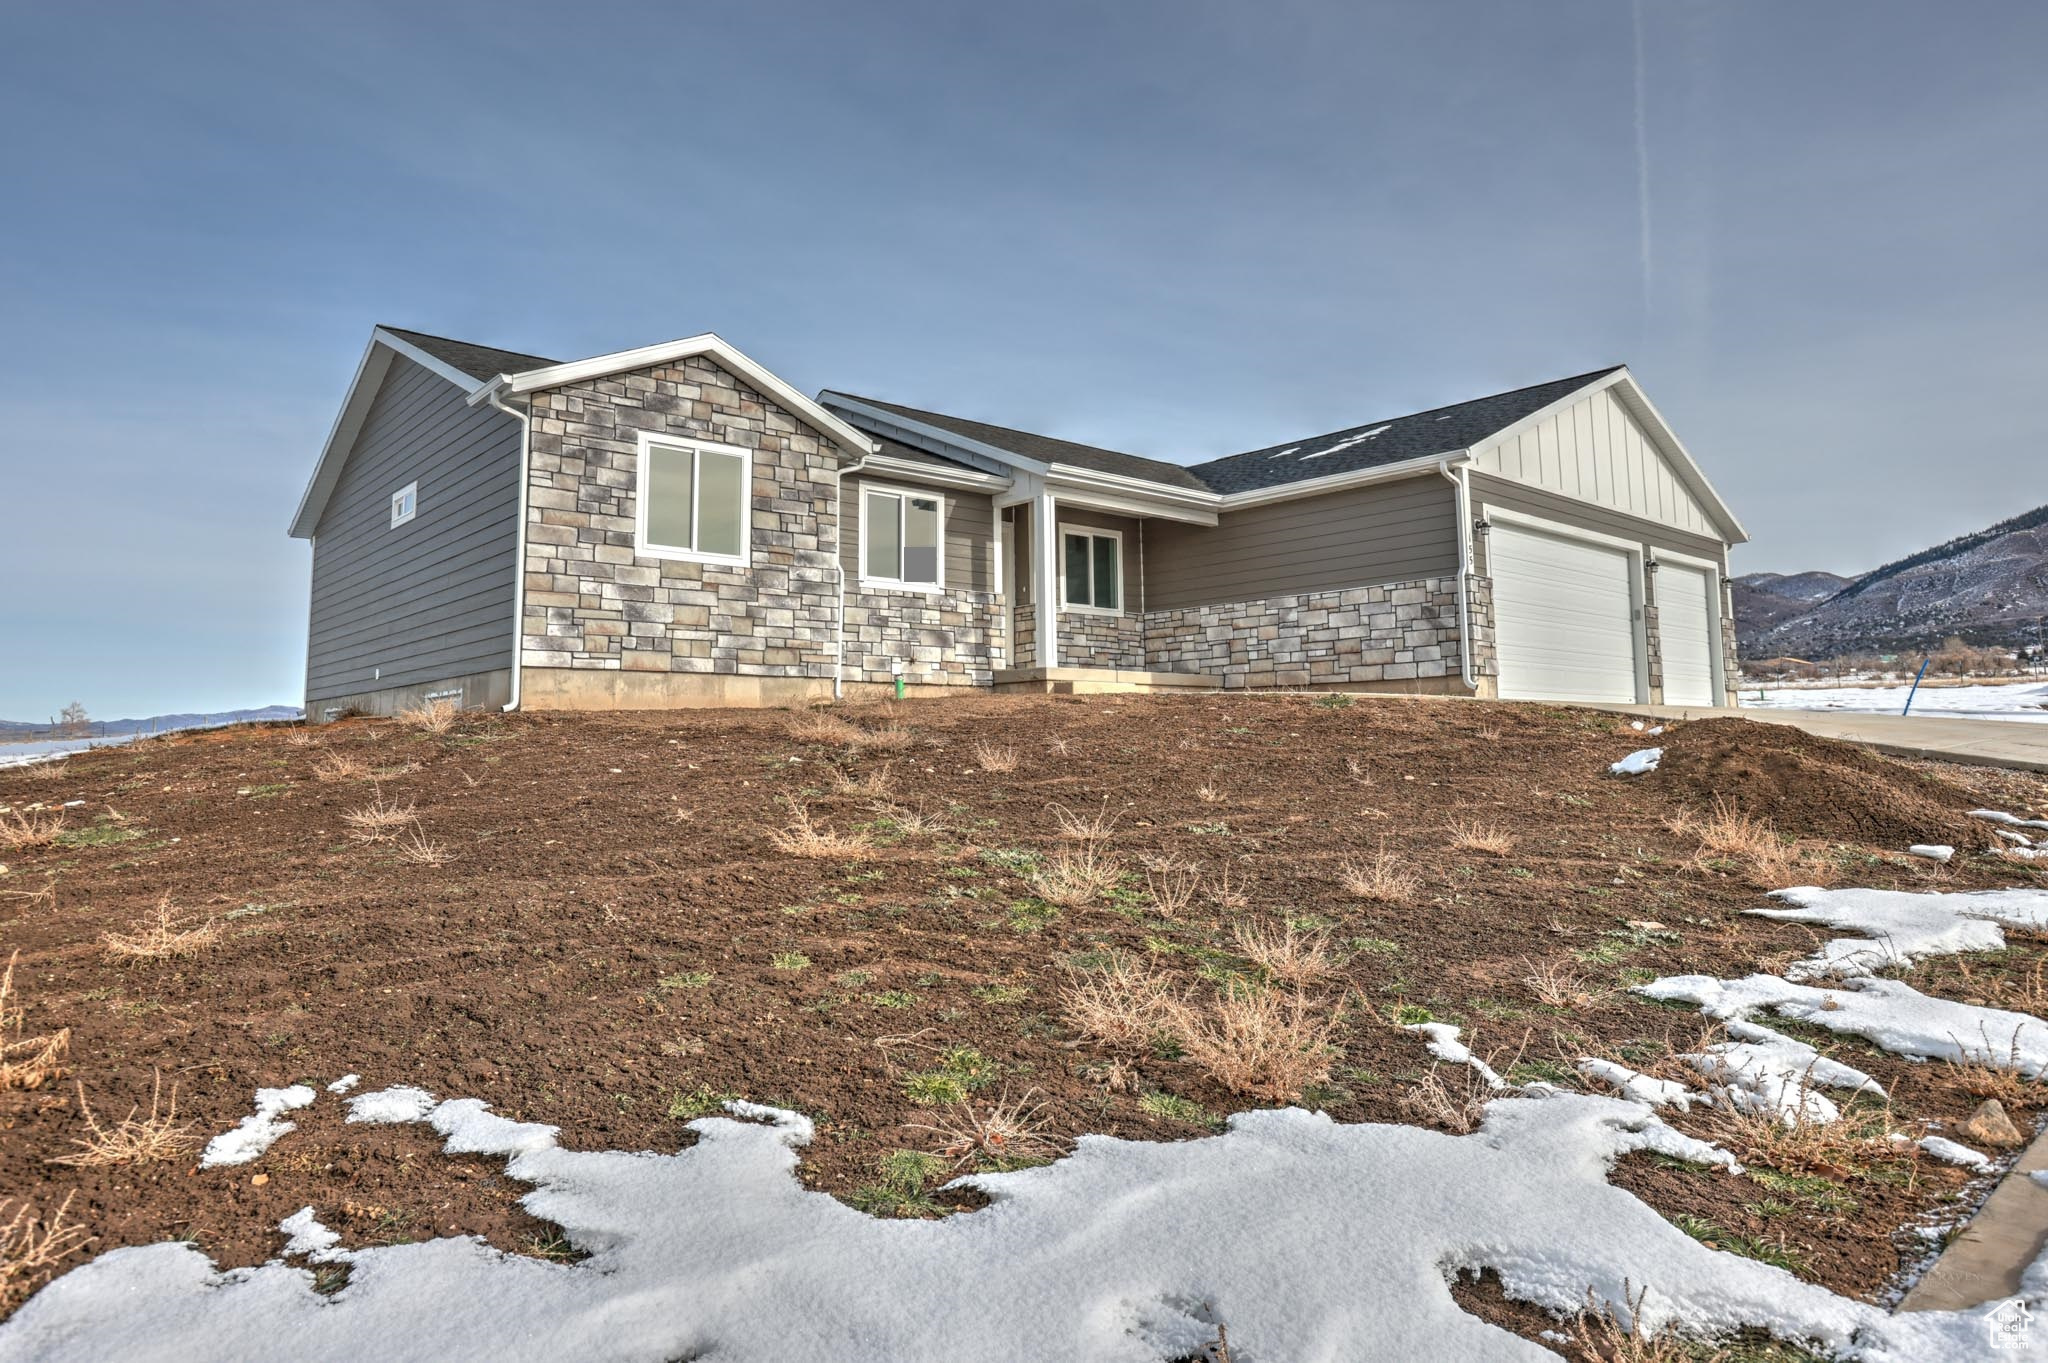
xmin=1475 ymin=389 xmax=1720 ymax=542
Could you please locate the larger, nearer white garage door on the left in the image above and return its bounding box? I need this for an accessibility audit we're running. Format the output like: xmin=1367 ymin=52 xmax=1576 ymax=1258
xmin=1489 ymin=524 xmax=1636 ymax=702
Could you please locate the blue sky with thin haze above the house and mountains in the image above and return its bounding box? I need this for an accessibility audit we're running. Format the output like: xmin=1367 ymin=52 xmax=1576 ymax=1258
xmin=0 ymin=0 xmax=2048 ymax=718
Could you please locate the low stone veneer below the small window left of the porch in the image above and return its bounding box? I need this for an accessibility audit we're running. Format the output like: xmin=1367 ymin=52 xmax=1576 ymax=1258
xmin=844 ymin=581 xmax=1010 ymax=686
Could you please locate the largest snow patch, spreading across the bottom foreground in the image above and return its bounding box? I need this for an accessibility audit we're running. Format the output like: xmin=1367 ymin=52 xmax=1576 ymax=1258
xmin=0 ymin=1095 xmax=2048 ymax=1363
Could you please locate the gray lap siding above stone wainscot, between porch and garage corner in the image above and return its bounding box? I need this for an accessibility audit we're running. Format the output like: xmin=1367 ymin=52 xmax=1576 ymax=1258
xmin=1145 ymin=473 xmax=1458 ymax=610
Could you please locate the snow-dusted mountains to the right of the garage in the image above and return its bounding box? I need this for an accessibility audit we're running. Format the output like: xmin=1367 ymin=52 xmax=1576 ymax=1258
xmin=1731 ymin=505 xmax=2048 ymax=659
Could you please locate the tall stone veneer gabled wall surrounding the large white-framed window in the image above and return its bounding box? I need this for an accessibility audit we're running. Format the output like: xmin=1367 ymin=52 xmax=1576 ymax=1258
xmin=520 ymin=358 xmax=838 ymax=679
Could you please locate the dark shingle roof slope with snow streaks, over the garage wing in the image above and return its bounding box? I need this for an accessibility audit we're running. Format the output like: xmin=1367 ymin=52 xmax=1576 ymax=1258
xmin=1190 ymin=364 xmax=1622 ymax=493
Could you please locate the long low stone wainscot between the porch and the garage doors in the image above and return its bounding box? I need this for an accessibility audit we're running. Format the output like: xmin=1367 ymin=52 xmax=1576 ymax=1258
xmin=1145 ymin=577 xmax=1493 ymax=688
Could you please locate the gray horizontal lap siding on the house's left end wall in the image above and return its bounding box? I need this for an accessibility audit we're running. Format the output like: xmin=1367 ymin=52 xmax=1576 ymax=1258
xmin=305 ymin=356 xmax=518 ymax=710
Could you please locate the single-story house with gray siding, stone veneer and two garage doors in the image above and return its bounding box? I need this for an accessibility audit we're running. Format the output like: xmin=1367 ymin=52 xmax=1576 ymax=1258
xmin=291 ymin=327 xmax=1745 ymax=720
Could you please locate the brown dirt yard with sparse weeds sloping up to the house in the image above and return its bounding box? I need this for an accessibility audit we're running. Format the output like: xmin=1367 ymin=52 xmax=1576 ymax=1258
xmin=0 ymin=696 xmax=2048 ymax=1332
